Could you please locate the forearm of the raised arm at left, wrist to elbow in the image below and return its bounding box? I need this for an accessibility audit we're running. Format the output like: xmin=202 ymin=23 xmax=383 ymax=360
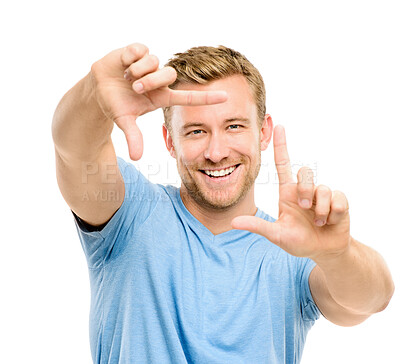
xmin=52 ymin=74 xmax=114 ymax=162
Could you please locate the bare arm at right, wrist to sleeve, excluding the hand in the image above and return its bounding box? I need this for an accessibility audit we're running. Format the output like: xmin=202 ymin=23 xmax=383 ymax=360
xmin=309 ymin=238 xmax=394 ymax=326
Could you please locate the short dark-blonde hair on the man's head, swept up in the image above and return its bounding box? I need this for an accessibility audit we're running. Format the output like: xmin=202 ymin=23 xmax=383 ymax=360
xmin=163 ymin=46 xmax=266 ymax=132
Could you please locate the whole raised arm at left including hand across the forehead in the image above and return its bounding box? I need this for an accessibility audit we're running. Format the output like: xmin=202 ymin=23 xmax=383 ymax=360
xmin=52 ymin=43 xmax=226 ymax=226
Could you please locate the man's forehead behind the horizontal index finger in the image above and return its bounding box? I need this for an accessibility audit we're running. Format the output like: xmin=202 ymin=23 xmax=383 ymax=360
xmin=171 ymin=75 xmax=257 ymax=129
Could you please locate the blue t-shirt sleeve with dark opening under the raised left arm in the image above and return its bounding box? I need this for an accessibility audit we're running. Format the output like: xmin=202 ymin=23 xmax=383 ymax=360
xmin=72 ymin=157 xmax=160 ymax=269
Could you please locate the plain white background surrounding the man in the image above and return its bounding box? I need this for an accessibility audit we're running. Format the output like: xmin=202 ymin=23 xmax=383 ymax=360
xmin=0 ymin=0 xmax=400 ymax=364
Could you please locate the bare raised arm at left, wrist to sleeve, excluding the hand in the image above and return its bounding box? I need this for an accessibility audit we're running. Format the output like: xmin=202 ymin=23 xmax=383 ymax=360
xmin=52 ymin=74 xmax=124 ymax=226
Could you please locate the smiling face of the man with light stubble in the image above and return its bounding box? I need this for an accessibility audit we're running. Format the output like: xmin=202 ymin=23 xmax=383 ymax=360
xmin=164 ymin=75 xmax=272 ymax=209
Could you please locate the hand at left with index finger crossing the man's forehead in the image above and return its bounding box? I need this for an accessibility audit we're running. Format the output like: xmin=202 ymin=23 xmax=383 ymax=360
xmin=90 ymin=43 xmax=227 ymax=160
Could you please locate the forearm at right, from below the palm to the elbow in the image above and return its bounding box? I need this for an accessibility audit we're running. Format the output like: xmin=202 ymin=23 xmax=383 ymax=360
xmin=316 ymin=238 xmax=394 ymax=314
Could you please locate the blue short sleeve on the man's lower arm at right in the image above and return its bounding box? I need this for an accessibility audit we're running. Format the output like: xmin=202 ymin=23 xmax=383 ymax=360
xmin=296 ymin=258 xmax=321 ymax=322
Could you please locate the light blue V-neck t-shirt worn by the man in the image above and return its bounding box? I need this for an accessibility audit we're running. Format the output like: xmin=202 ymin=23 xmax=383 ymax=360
xmin=75 ymin=158 xmax=320 ymax=364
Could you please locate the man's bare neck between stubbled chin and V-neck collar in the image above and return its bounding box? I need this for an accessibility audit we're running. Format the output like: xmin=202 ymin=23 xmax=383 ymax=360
xmin=180 ymin=186 xmax=257 ymax=235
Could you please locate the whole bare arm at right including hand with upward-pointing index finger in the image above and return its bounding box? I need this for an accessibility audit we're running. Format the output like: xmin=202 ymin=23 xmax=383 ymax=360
xmin=232 ymin=126 xmax=394 ymax=326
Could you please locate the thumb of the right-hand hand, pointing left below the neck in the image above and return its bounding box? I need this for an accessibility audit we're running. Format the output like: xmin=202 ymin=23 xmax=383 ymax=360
xmin=231 ymin=216 xmax=281 ymax=245
